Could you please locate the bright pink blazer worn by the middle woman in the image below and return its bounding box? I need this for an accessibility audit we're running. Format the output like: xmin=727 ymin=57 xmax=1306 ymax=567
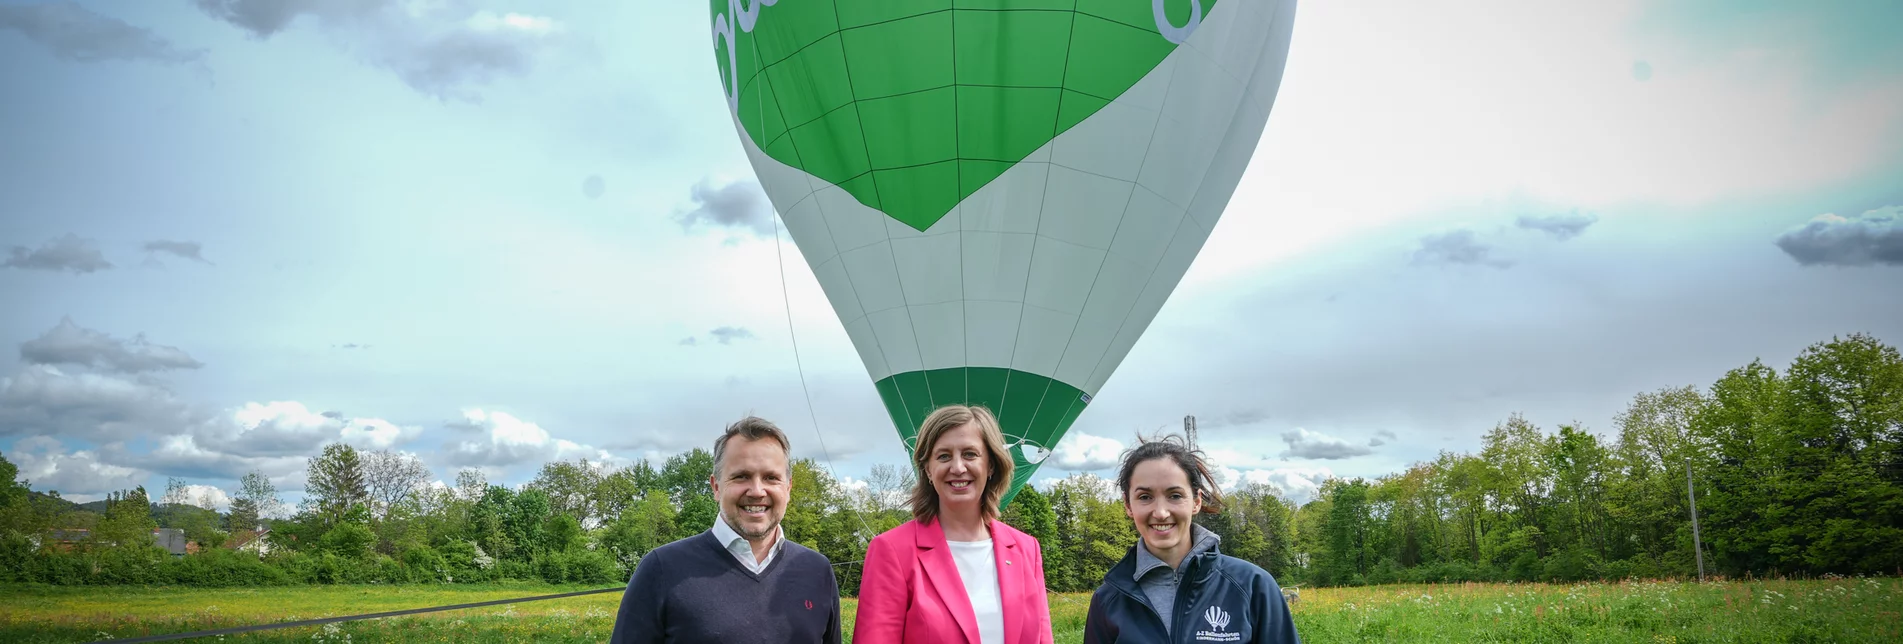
xmin=853 ymin=520 xmax=1050 ymax=644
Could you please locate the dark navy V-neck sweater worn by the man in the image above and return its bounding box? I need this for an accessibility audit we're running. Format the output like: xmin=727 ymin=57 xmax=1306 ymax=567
xmin=611 ymin=529 xmax=839 ymax=644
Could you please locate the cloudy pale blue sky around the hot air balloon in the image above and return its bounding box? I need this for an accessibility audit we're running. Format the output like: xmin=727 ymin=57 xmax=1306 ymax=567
xmin=0 ymin=0 xmax=1903 ymax=507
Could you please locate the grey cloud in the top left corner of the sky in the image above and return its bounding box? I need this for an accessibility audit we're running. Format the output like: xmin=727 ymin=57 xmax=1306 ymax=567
xmin=0 ymin=2 xmax=206 ymax=63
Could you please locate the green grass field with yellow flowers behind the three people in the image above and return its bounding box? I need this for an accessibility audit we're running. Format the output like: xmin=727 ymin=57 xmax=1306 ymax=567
xmin=0 ymin=579 xmax=1903 ymax=642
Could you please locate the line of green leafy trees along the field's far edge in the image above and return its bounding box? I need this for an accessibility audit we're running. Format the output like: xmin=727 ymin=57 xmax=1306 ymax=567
xmin=0 ymin=333 xmax=1903 ymax=594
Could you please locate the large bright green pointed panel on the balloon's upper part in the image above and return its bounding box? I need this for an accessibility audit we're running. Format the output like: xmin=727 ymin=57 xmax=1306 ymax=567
xmin=710 ymin=0 xmax=1220 ymax=231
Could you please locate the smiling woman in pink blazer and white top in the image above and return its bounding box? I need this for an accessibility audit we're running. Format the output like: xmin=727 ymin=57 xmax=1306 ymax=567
xmin=853 ymin=406 xmax=1050 ymax=644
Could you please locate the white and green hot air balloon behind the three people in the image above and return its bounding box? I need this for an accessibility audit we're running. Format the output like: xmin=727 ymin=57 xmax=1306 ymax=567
xmin=712 ymin=0 xmax=1296 ymax=503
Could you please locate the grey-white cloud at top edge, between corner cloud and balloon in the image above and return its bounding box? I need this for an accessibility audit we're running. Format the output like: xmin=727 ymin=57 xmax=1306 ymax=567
xmin=196 ymin=0 xmax=563 ymax=103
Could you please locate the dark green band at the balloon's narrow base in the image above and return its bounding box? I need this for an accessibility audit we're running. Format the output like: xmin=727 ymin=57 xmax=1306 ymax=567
xmin=875 ymin=368 xmax=1090 ymax=505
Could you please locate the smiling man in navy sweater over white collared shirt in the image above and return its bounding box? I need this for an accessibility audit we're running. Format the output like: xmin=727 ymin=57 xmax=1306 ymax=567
xmin=611 ymin=417 xmax=839 ymax=644
